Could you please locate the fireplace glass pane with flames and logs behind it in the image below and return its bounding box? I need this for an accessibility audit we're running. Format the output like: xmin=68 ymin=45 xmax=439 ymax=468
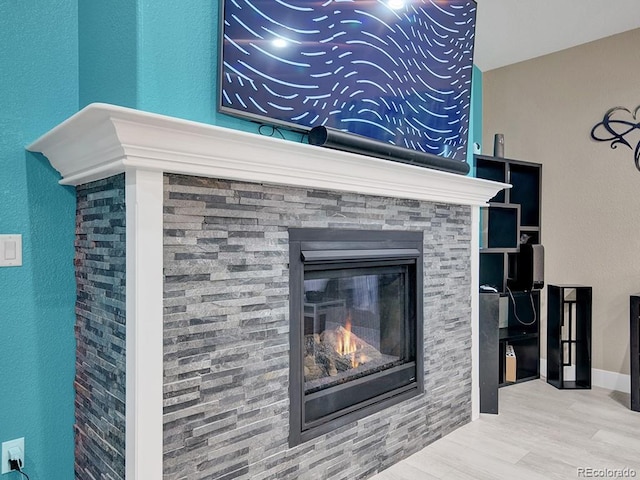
xmin=304 ymin=265 xmax=415 ymax=395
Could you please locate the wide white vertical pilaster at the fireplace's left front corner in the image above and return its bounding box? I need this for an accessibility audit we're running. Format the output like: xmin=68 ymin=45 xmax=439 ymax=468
xmin=125 ymin=170 xmax=164 ymax=480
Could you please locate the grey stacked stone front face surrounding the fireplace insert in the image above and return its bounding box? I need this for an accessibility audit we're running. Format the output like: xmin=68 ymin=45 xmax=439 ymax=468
xmin=163 ymin=175 xmax=471 ymax=480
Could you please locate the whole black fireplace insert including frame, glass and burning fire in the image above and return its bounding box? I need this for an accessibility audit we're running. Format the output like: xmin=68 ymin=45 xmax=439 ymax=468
xmin=289 ymin=229 xmax=424 ymax=445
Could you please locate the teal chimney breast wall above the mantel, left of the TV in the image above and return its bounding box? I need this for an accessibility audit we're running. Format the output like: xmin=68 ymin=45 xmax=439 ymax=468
xmin=79 ymin=0 xmax=249 ymax=132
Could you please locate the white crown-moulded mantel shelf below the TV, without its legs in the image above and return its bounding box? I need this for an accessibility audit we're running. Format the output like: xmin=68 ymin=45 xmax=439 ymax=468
xmin=27 ymin=104 xmax=510 ymax=205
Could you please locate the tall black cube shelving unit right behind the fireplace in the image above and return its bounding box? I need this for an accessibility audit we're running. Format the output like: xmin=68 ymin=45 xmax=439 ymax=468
xmin=475 ymin=155 xmax=542 ymax=388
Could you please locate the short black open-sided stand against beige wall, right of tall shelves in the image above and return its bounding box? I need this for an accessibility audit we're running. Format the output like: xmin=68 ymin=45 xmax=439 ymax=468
xmin=547 ymin=285 xmax=592 ymax=389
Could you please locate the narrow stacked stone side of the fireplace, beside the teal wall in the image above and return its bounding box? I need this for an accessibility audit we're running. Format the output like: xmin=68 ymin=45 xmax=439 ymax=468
xmin=75 ymin=175 xmax=126 ymax=480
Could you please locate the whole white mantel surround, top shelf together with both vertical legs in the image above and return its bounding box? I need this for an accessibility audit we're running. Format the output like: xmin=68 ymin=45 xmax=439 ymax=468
xmin=27 ymin=104 xmax=510 ymax=480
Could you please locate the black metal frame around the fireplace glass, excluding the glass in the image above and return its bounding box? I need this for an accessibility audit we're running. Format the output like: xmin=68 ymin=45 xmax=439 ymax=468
xmin=289 ymin=228 xmax=424 ymax=447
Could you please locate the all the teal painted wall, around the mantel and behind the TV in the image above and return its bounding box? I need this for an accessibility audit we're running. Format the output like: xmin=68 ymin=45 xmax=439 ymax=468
xmin=0 ymin=0 xmax=482 ymax=480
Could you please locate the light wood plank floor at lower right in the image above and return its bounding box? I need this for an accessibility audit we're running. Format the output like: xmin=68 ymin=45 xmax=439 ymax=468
xmin=372 ymin=380 xmax=640 ymax=480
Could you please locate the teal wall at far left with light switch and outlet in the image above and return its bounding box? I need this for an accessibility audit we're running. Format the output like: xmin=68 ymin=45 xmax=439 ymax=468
xmin=0 ymin=0 xmax=78 ymax=480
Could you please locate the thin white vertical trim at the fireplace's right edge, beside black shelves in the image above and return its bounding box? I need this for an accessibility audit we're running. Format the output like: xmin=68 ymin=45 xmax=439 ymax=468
xmin=471 ymin=207 xmax=480 ymax=421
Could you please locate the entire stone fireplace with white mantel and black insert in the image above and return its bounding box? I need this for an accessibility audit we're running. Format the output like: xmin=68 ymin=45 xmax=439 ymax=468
xmin=29 ymin=105 xmax=505 ymax=480
